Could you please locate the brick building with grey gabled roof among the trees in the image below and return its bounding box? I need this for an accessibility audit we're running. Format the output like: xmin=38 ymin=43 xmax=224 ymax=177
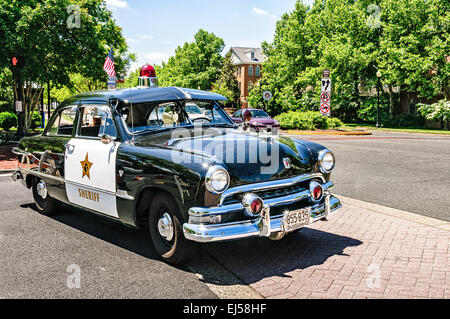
xmin=230 ymin=47 xmax=265 ymax=108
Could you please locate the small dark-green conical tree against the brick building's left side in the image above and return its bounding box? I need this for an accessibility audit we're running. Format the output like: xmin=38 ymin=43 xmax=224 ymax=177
xmin=213 ymin=52 xmax=240 ymax=105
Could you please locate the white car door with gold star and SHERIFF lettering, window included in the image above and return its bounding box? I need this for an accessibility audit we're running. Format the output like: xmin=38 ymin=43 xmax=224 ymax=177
xmin=64 ymin=104 xmax=120 ymax=218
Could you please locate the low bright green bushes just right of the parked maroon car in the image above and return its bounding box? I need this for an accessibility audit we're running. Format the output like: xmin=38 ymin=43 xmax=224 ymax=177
xmin=275 ymin=111 xmax=343 ymax=130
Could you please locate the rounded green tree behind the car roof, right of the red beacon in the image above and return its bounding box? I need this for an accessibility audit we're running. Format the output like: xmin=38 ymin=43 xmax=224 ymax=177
xmin=157 ymin=29 xmax=225 ymax=90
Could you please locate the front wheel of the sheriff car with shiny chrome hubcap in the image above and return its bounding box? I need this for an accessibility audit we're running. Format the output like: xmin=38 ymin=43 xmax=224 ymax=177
xmin=148 ymin=193 xmax=195 ymax=265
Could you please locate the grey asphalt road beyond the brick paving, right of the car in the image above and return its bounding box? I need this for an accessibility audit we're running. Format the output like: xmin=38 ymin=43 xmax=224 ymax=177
xmin=286 ymin=132 xmax=450 ymax=221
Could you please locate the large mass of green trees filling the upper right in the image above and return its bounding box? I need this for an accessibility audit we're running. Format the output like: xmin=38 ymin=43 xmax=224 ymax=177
xmin=255 ymin=0 xmax=450 ymax=122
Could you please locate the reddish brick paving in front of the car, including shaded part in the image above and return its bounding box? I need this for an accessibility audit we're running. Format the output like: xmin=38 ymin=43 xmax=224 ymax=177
xmin=205 ymin=205 xmax=450 ymax=298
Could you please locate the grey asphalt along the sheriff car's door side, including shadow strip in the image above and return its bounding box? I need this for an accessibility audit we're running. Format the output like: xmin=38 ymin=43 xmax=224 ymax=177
xmin=0 ymin=182 xmax=217 ymax=298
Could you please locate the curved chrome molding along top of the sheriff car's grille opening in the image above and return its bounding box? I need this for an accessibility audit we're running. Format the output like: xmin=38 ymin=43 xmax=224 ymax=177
xmin=218 ymin=173 xmax=325 ymax=206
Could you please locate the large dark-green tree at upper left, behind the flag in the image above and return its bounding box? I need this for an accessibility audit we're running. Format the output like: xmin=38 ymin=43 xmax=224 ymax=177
xmin=0 ymin=0 xmax=133 ymax=134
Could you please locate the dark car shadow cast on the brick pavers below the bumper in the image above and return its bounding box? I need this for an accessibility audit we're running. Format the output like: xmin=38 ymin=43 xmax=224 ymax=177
xmin=195 ymin=228 xmax=362 ymax=284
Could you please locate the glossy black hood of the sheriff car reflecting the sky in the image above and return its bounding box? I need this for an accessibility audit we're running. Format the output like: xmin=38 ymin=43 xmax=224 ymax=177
xmin=134 ymin=128 xmax=324 ymax=185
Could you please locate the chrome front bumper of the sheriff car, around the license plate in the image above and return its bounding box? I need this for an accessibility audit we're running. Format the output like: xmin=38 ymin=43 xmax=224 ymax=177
xmin=183 ymin=191 xmax=342 ymax=243
